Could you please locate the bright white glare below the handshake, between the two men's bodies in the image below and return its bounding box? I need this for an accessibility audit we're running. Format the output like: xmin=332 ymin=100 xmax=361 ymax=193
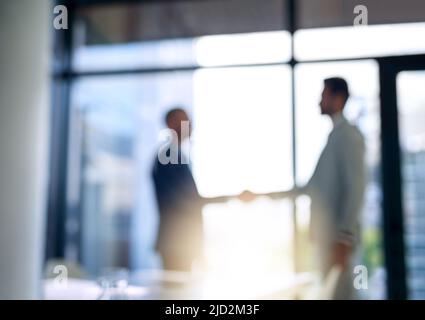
xmin=200 ymin=198 xmax=293 ymax=298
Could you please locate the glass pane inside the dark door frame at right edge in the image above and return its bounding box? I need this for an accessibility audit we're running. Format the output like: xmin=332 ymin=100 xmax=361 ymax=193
xmin=397 ymin=71 xmax=425 ymax=299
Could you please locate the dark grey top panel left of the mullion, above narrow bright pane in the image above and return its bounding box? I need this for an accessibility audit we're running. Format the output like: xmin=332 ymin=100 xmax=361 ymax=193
xmin=77 ymin=0 xmax=287 ymax=44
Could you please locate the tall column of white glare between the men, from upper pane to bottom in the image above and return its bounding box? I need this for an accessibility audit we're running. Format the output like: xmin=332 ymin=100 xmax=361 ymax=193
xmin=192 ymin=44 xmax=293 ymax=298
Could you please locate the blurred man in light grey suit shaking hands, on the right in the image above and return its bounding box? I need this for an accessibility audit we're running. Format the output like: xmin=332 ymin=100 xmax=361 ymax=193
xmin=245 ymin=78 xmax=365 ymax=299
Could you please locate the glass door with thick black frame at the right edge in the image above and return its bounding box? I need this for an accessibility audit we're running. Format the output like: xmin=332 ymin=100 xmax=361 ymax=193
xmin=380 ymin=55 xmax=425 ymax=299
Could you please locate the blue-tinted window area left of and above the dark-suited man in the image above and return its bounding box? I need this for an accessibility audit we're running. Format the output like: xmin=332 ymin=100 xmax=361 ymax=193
xmin=68 ymin=72 xmax=193 ymax=275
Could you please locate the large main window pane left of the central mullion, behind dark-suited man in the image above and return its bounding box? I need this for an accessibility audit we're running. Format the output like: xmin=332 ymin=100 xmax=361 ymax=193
xmin=67 ymin=66 xmax=293 ymax=293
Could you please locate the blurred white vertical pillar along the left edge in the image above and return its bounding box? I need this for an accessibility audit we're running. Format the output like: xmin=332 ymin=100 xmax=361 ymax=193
xmin=0 ymin=0 xmax=53 ymax=299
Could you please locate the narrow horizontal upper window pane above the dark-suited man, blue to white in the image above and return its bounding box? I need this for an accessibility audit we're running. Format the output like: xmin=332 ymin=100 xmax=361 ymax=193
xmin=73 ymin=31 xmax=291 ymax=71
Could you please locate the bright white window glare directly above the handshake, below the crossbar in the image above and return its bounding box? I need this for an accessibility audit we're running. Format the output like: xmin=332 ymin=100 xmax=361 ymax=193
xmin=192 ymin=66 xmax=293 ymax=196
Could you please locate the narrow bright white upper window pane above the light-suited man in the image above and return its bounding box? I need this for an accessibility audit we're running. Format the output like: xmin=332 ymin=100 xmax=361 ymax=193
xmin=294 ymin=23 xmax=425 ymax=60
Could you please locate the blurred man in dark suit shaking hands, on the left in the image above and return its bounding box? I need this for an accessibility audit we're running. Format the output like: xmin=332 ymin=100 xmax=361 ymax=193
xmin=152 ymin=108 xmax=229 ymax=271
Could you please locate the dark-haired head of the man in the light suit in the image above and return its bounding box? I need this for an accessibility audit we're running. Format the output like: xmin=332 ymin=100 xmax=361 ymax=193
xmin=319 ymin=77 xmax=350 ymax=116
